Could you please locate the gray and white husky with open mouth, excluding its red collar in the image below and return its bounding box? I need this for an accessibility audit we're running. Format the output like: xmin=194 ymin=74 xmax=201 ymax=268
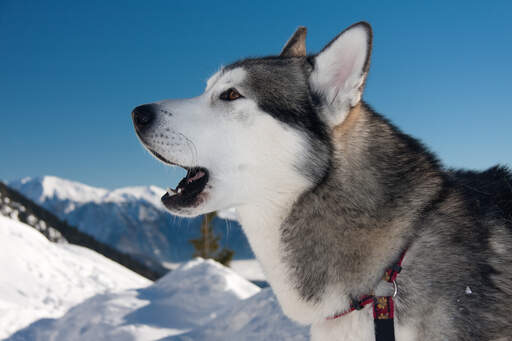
xmin=132 ymin=22 xmax=512 ymax=341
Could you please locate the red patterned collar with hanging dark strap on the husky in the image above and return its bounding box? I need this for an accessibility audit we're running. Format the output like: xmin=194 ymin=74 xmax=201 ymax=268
xmin=327 ymin=250 xmax=407 ymax=341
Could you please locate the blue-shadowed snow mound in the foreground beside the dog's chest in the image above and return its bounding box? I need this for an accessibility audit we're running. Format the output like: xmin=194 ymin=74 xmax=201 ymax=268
xmin=9 ymin=259 xmax=308 ymax=341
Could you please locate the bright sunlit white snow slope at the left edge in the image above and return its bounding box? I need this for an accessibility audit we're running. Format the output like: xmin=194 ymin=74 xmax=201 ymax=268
xmin=0 ymin=216 xmax=150 ymax=339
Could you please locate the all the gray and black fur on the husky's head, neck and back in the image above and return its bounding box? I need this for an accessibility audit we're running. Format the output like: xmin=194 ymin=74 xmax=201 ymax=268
xmin=228 ymin=35 xmax=512 ymax=340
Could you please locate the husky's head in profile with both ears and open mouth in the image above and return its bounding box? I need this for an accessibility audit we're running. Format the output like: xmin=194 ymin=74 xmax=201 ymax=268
xmin=132 ymin=23 xmax=371 ymax=216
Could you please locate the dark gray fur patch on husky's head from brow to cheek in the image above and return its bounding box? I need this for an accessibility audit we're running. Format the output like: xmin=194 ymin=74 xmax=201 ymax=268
xmin=225 ymin=57 xmax=332 ymax=183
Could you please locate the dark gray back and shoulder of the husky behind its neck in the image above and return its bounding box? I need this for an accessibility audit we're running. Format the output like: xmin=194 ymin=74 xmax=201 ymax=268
xmin=401 ymin=166 xmax=512 ymax=340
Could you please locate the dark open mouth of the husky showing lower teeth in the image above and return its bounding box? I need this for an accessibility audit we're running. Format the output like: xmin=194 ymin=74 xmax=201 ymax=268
xmin=162 ymin=167 xmax=208 ymax=209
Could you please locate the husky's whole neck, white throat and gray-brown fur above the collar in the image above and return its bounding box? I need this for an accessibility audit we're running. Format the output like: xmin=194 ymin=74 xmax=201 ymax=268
xmin=239 ymin=104 xmax=442 ymax=323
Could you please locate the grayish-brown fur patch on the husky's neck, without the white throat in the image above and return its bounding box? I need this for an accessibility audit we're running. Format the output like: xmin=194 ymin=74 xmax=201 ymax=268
xmin=282 ymin=108 xmax=441 ymax=300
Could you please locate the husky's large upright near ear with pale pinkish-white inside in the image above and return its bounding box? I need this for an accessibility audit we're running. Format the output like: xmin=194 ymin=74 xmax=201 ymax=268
xmin=310 ymin=22 xmax=372 ymax=127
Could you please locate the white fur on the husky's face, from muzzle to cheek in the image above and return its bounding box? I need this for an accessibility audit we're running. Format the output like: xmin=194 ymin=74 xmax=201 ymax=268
xmin=146 ymin=68 xmax=316 ymax=218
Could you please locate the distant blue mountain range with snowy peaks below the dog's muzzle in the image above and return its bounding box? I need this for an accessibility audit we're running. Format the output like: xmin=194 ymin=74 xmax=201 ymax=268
xmin=8 ymin=176 xmax=253 ymax=264
